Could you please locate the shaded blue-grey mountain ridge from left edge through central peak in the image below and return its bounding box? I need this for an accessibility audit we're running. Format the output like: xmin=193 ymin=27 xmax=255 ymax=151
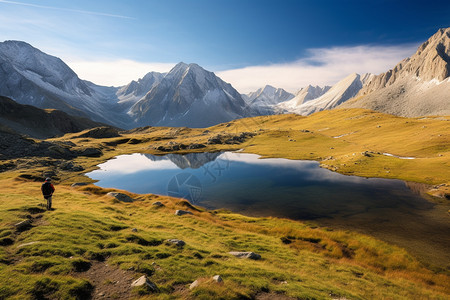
xmin=0 ymin=41 xmax=249 ymax=129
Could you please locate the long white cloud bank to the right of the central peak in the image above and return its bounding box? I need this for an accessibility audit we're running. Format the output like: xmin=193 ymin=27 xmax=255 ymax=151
xmin=216 ymin=44 xmax=418 ymax=93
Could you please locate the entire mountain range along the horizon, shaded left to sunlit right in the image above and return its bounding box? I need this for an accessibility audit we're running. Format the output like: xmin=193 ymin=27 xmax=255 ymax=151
xmin=0 ymin=28 xmax=450 ymax=129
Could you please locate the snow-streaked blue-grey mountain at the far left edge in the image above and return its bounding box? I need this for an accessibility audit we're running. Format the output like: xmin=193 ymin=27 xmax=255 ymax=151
xmin=0 ymin=41 xmax=128 ymax=122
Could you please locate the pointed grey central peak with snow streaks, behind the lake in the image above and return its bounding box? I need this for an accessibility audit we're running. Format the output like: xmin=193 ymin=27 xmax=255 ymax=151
xmin=129 ymin=63 xmax=247 ymax=127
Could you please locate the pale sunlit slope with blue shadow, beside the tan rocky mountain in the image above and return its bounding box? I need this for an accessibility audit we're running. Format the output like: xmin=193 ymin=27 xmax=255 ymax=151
xmin=279 ymin=73 xmax=371 ymax=116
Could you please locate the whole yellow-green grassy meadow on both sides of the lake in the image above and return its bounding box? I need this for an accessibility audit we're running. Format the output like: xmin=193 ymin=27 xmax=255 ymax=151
xmin=0 ymin=110 xmax=450 ymax=299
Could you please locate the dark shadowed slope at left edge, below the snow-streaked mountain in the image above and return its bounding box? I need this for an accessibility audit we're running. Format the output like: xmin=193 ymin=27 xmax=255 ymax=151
xmin=0 ymin=96 xmax=105 ymax=139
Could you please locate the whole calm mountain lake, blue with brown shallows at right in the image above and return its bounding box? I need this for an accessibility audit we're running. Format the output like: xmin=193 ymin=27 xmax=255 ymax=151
xmin=87 ymin=152 xmax=450 ymax=262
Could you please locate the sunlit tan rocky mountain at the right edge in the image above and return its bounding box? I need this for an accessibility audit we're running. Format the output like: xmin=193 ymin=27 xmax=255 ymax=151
xmin=341 ymin=28 xmax=450 ymax=117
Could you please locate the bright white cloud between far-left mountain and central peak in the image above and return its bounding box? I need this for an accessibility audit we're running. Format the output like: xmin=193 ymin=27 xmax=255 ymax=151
xmin=64 ymin=59 xmax=175 ymax=86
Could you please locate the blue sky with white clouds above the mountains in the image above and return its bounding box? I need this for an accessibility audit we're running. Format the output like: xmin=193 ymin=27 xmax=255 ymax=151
xmin=0 ymin=0 xmax=450 ymax=92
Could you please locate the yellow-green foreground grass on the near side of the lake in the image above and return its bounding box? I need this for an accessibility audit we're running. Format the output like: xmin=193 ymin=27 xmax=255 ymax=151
xmin=0 ymin=176 xmax=450 ymax=299
